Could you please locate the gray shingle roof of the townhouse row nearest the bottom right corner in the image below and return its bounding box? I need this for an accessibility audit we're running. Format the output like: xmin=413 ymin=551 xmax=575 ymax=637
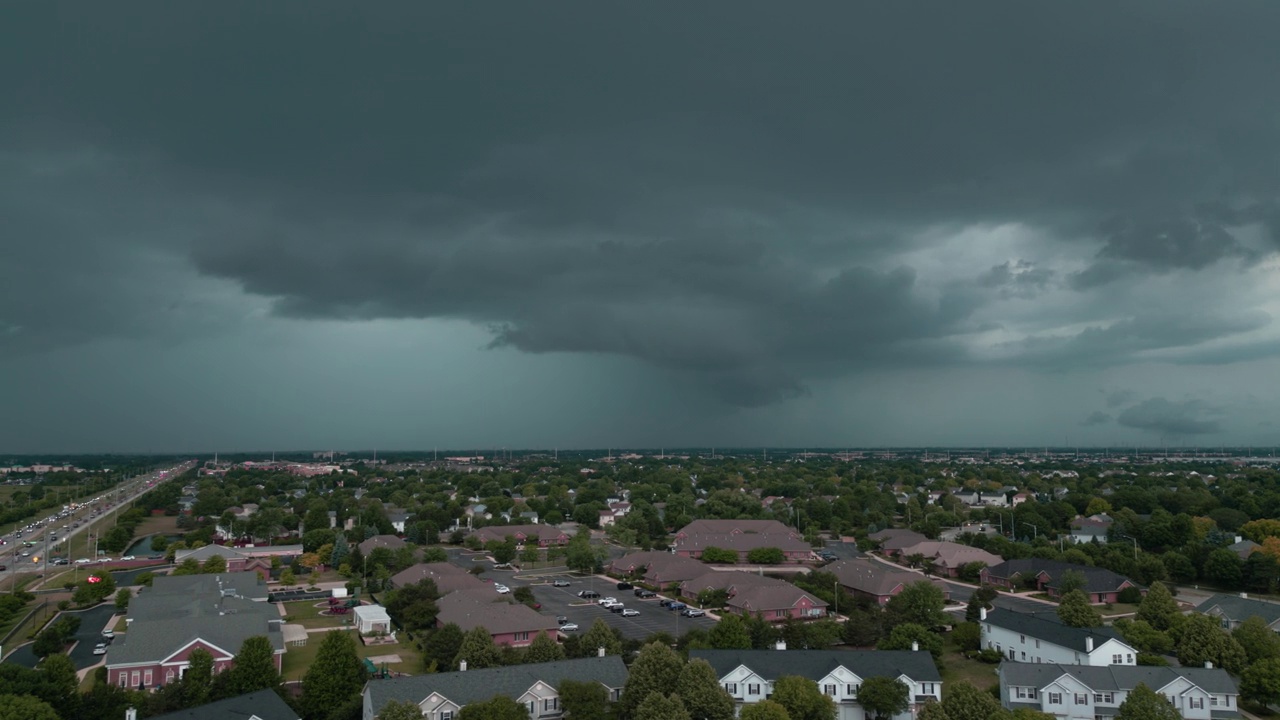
xmin=1000 ymin=662 xmax=1239 ymax=694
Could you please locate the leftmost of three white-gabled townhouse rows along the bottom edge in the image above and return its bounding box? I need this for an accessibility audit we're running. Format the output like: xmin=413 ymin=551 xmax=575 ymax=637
xmin=362 ymin=655 xmax=627 ymax=720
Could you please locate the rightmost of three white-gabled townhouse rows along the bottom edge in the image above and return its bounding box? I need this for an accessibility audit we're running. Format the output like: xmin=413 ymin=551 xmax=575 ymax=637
xmin=997 ymin=662 xmax=1240 ymax=720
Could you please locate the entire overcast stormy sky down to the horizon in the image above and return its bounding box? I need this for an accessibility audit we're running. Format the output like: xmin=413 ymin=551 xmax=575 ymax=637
xmin=0 ymin=0 xmax=1280 ymax=452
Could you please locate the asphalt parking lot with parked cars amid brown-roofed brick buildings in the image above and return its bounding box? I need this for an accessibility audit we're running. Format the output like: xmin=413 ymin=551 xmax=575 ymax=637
xmin=524 ymin=578 xmax=716 ymax=639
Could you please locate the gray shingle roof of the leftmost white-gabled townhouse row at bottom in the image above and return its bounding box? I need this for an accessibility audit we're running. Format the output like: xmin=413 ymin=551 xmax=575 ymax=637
xmin=365 ymin=655 xmax=627 ymax=715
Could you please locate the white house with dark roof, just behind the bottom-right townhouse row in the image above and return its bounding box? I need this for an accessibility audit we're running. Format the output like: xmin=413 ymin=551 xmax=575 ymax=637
xmin=978 ymin=609 xmax=1138 ymax=666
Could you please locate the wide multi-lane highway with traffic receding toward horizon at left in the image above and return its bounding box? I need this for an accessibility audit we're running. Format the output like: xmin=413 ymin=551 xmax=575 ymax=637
xmin=0 ymin=461 xmax=195 ymax=591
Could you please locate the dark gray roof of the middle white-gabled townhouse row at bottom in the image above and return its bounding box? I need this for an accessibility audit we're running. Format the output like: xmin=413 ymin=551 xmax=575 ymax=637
xmin=689 ymin=650 xmax=942 ymax=683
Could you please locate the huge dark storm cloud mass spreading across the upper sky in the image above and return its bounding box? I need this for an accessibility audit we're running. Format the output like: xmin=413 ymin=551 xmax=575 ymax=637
xmin=0 ymin=1 xmax=1280 ymax=405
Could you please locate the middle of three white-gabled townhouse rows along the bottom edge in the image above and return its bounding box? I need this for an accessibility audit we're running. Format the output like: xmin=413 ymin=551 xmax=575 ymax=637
xmin=689 ymin=643 xmax=942 ymax=720
